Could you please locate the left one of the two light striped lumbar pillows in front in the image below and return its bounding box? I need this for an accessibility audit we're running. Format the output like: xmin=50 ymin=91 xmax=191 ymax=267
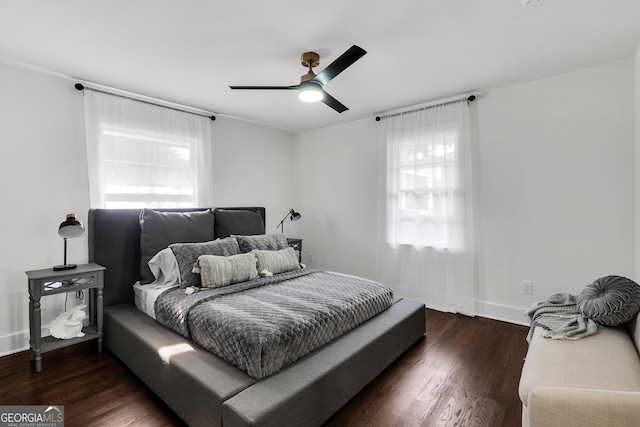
xmin=193 ymin=254 xmax=258 ymax=288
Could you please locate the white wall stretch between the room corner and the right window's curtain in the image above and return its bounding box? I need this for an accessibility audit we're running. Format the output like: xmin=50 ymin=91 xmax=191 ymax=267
xmin=294 ymin=118 xmax=378 ymax=279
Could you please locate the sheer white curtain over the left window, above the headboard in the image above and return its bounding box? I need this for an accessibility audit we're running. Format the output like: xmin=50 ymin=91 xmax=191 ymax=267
xmin=84 ymin=89 xmax=213 ymax=208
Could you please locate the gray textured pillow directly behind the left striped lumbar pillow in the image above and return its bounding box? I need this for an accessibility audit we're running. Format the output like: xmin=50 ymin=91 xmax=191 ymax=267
xmin=169 ymin=237 xmax=240 ymax=288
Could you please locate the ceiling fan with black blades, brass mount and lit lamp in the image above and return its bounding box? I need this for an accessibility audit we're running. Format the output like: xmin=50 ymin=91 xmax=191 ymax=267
xmin=229 ymin=45 xmax=367 ymax=113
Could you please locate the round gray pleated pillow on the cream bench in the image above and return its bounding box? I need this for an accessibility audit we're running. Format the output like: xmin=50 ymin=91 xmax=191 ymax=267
xmin=577 ymin=276 xmax=640 ymax=326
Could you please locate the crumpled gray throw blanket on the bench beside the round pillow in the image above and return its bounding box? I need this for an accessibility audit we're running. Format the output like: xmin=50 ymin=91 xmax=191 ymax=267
xmin=527 ymin=294 xmax=598 ymax=342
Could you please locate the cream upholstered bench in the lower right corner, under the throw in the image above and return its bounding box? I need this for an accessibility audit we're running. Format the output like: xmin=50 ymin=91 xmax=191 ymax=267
xmin=519 ymin=276 xmax=640 ymax=427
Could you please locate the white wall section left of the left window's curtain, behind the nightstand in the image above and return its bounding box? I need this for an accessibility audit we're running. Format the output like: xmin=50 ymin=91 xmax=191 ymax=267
xmin=0 ymin=64 xmax=89 ymax=354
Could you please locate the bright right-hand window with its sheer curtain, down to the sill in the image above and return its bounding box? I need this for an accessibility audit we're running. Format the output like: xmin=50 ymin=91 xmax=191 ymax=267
xmin=385 ymin=102 xmax=468 ymax=251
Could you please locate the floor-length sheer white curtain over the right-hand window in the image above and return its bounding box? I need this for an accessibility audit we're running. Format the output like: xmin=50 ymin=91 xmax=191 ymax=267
xmin=377 ymin=100 xmax=478 ymax=315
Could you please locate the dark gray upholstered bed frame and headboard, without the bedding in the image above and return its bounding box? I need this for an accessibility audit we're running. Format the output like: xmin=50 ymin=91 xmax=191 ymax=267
xmin=88 ymin=207 xmax=426 ymax=427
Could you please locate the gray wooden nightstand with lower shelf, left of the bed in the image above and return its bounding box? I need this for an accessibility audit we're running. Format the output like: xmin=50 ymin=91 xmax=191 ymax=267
xmin=26 ymin=264 xmax=105 ymax=372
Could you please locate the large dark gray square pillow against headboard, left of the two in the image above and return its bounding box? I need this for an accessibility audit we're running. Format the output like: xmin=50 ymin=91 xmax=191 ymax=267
xmin=140 ymin=209 xmax=213 ymax=284
